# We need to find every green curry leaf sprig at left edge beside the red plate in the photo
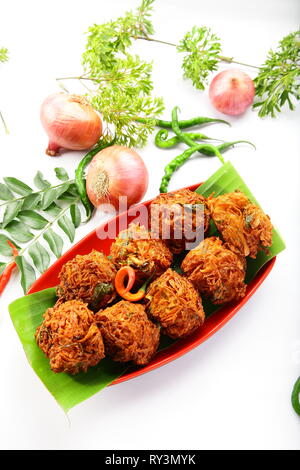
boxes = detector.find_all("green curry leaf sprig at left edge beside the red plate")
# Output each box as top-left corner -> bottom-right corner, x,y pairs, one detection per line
0,168 -> 81,292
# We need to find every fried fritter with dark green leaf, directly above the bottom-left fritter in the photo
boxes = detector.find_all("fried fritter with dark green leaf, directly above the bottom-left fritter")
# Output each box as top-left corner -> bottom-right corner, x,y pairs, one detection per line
57,250 -> 116,311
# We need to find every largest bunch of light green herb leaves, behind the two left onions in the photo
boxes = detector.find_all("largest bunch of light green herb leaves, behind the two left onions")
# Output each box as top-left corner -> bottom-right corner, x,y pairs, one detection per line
82,0 -> 164,146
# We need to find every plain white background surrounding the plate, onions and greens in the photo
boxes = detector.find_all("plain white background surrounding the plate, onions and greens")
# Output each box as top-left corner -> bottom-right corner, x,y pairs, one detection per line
0,0 -> 300,449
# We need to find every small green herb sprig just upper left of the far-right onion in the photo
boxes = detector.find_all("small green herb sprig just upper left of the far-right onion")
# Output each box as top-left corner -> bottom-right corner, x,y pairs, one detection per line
177,26 -> 221,90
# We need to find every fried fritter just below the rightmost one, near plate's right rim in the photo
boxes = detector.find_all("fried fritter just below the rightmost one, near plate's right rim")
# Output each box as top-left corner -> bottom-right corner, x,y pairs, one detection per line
181,237 -> 246,304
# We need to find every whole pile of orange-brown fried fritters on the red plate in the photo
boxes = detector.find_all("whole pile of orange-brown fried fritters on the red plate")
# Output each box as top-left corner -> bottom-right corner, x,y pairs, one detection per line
36,190 -> 272,374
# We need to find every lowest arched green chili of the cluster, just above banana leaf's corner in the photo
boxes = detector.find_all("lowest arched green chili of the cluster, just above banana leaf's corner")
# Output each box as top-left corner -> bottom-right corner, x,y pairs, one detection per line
159,143 -> 224,193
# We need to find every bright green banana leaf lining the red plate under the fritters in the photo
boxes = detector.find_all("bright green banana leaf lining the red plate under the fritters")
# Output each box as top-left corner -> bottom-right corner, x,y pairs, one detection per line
9,162 -> 285,411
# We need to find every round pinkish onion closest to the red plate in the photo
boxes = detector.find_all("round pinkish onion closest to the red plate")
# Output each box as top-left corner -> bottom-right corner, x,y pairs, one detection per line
86,145 -> 149,209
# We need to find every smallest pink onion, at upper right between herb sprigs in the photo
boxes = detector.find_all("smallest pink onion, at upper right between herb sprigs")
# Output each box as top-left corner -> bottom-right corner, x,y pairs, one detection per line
209,69 -> 255,116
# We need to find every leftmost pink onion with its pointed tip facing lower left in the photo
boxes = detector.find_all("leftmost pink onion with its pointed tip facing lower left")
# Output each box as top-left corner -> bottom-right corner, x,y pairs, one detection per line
40,93 -> 102,156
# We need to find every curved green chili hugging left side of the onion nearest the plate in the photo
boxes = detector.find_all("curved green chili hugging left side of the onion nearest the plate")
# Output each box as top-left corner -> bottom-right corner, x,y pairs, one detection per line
75,139 -> 115,222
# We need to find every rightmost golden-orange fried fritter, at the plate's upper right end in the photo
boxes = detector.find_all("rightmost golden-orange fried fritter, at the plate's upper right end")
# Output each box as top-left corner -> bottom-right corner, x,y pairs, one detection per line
207,191 -> 273,258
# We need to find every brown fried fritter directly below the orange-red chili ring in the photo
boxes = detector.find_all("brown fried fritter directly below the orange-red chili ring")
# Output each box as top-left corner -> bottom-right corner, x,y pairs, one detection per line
96,300 -> 160,365
